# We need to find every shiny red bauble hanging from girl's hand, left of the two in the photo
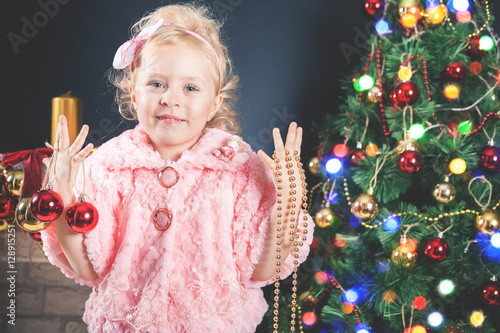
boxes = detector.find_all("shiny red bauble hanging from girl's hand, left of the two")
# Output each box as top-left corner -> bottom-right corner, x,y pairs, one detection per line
30,190 -> 64,222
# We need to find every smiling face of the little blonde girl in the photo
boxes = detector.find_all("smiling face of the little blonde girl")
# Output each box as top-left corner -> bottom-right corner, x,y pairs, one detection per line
131,44 -> 222,160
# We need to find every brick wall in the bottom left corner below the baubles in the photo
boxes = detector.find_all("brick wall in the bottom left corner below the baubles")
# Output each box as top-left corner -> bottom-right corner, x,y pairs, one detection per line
0,226 -> 91,333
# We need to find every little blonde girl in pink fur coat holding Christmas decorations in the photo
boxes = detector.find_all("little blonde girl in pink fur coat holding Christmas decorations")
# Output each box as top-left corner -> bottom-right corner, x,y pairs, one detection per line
42,5 -> 313,333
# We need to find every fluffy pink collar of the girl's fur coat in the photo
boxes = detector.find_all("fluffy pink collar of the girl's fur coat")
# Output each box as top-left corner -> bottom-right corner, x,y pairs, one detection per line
89,124 -> 251,171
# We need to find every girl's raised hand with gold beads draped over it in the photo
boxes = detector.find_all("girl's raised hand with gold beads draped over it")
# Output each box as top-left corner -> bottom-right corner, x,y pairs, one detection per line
258,122 -> 303,201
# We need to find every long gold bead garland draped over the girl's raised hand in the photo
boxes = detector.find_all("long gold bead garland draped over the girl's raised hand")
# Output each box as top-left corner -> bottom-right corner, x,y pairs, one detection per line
273,150 -> 308,333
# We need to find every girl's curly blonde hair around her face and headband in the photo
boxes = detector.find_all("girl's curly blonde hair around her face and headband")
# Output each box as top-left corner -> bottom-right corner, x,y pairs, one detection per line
108,4 -> 241,134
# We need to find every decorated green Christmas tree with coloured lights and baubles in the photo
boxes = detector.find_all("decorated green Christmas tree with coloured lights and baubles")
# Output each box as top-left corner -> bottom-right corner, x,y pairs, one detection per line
286,0 -> 500,333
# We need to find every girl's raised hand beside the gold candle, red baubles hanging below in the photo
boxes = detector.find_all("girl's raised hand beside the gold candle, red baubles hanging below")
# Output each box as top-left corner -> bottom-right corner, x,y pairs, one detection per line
43,116 -> 94,204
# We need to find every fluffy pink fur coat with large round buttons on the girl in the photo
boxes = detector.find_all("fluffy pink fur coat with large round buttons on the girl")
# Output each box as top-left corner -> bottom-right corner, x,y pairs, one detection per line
42,125 -> 313,333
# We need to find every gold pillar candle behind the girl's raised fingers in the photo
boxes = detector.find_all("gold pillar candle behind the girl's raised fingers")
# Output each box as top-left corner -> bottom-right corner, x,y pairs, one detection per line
52,91 -> 82,145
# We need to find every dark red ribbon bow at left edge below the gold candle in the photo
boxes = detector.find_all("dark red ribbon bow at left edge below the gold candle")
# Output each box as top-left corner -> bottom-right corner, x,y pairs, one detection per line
2,148 -> 52,199
